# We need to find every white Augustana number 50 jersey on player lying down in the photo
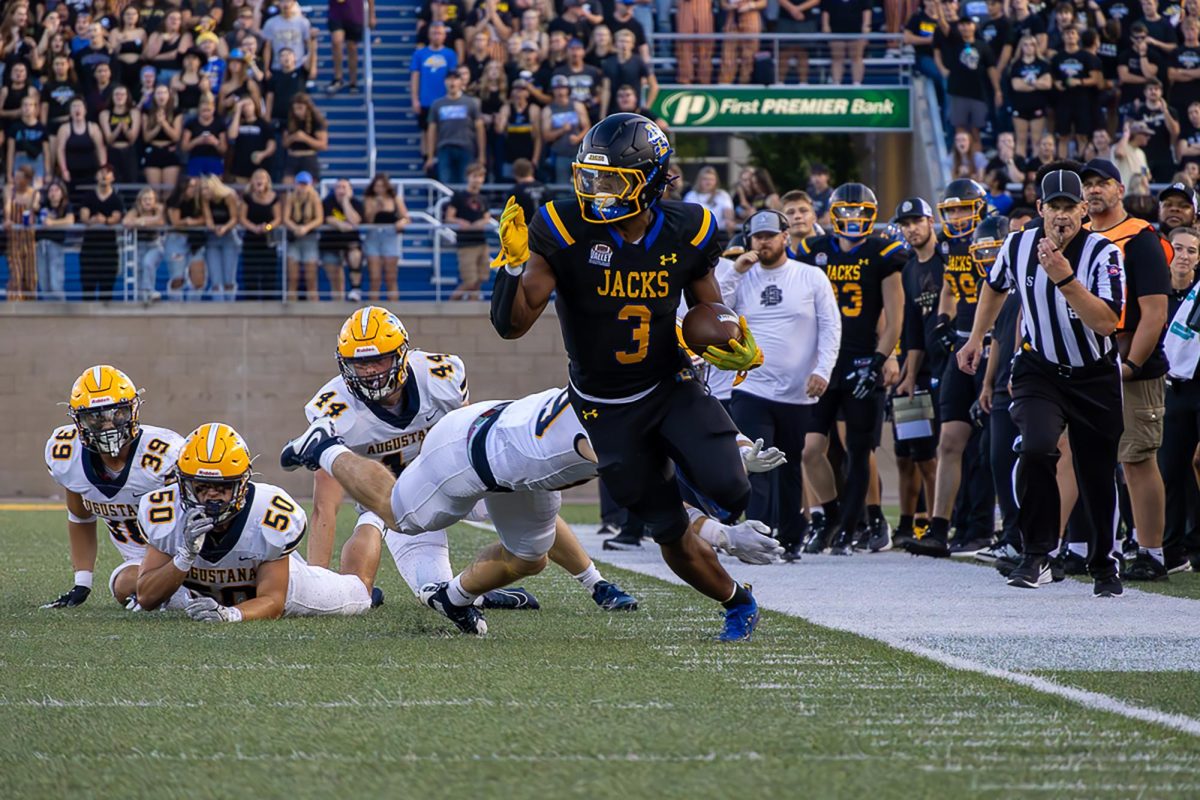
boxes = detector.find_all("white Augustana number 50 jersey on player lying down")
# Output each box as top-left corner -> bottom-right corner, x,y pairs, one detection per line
138,481 -> 308,606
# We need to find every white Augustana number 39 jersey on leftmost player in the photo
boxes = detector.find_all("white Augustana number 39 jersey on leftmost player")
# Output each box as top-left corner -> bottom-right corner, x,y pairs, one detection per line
46,425 -> 184,560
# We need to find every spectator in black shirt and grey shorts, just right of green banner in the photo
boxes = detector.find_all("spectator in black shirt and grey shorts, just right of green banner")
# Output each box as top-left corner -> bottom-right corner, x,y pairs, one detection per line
935,17 -> 1003,138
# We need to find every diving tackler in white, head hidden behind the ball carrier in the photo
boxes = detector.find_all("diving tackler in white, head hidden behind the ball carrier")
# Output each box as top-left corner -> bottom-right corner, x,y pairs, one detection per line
280,389 -> 784,634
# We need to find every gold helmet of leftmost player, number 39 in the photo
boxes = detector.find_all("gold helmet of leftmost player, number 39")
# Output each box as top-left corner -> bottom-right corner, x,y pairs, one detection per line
67,363 -> 142,457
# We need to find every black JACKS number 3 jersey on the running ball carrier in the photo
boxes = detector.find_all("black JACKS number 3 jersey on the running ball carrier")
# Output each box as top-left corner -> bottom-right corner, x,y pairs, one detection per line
529,200 -> 721,398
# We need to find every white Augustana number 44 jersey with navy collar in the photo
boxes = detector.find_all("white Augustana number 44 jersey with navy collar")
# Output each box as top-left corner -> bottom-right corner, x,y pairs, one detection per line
304,350 -> 469,475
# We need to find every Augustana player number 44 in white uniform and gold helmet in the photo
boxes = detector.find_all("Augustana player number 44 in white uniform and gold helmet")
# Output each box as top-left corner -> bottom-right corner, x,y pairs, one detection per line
305,306 -> 637,610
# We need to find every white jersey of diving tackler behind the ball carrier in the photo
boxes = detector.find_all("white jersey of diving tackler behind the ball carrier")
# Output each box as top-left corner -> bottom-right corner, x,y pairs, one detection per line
480,389 -> 596,492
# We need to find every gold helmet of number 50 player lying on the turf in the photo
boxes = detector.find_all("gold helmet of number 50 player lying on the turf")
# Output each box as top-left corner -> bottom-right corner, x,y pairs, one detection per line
175,422 -> 252,524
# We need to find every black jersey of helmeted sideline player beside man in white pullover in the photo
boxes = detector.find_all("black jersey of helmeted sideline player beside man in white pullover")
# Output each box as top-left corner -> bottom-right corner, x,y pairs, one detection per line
797,235 -> 906,357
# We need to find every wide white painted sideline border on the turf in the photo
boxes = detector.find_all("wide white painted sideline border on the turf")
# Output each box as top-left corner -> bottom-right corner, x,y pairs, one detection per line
575,525 -> 1200,736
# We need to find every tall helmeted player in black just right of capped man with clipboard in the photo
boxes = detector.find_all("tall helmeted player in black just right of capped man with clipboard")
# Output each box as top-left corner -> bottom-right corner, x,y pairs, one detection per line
905,178 -> 995,558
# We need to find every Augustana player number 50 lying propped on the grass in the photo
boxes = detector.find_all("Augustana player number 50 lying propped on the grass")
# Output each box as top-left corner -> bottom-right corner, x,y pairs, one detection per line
138,422 -> 372,622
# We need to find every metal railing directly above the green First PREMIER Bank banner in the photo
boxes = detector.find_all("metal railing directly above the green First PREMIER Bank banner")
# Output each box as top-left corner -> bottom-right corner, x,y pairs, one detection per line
652,31 -> 913,85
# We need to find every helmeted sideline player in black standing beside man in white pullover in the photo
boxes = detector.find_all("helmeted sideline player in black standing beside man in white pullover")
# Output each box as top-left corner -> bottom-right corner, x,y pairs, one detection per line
790,184 -> 905,558
